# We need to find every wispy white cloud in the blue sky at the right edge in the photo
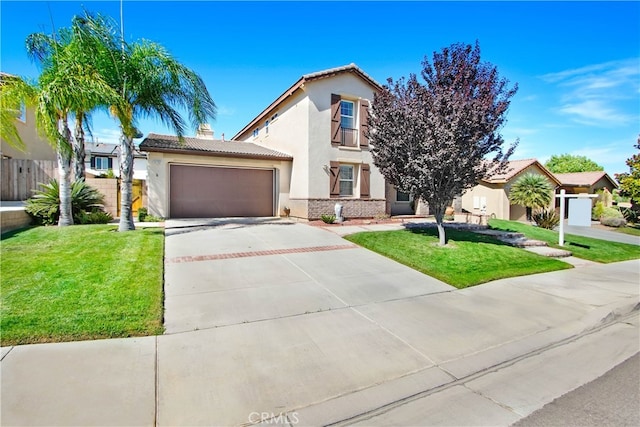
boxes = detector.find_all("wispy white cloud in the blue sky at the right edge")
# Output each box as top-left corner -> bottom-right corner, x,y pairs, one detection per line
541,58 -> 640,127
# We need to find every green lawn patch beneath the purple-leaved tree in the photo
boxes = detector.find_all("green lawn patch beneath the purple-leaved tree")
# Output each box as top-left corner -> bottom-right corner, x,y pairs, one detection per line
345,228 -> 572,289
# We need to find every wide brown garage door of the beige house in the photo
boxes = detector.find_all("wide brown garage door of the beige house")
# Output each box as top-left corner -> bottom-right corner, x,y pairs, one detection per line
169,165 -> 273,218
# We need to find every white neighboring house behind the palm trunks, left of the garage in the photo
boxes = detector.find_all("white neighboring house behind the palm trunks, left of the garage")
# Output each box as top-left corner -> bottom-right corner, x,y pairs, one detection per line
84,142 -> 147,180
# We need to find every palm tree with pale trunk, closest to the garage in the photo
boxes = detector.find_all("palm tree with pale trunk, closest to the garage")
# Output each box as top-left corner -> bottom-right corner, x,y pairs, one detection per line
77,15 -> 216,231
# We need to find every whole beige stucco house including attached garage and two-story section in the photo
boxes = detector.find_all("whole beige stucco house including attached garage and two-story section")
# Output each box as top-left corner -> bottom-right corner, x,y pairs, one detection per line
140,64 -> 396,219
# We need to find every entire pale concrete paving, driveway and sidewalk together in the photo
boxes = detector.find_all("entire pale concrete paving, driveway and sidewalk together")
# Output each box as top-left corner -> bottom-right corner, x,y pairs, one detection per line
0,219 -> 640,426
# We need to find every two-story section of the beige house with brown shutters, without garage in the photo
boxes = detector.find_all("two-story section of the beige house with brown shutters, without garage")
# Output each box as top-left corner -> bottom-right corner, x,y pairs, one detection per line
233,64 -> 385,218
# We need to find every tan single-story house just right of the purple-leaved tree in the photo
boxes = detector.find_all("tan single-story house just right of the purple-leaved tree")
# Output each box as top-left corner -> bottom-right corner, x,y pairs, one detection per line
462,159 -> 560,221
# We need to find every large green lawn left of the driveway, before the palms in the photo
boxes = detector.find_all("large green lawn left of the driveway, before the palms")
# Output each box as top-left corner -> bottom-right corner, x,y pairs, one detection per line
0,225 -> 164,346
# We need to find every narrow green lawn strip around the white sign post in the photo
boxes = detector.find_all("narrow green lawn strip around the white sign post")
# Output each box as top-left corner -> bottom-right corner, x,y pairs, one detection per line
489,219 -> 640,263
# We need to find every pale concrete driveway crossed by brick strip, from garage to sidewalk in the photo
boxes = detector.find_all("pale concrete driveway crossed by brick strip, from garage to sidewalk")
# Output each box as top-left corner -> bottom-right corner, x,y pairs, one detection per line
165,218 -> 454,334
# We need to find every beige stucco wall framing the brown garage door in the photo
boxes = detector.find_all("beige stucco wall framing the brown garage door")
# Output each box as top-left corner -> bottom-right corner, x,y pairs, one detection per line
147,152 -> 291,218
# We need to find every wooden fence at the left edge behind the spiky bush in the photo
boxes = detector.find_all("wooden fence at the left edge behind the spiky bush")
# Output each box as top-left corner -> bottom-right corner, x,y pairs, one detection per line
0,159 -> 58,201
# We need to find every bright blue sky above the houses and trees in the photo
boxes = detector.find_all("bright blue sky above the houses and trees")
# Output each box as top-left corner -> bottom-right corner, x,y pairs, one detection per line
0,0 -> 640,175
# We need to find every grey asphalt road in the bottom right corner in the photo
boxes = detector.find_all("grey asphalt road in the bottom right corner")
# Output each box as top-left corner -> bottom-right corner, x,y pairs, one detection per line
514,354 -> 640,427
